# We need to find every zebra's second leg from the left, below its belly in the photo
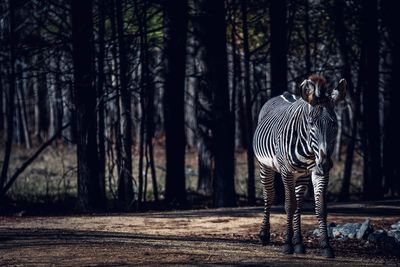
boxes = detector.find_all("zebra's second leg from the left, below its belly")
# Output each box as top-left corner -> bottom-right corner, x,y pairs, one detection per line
282,173 -> 297,254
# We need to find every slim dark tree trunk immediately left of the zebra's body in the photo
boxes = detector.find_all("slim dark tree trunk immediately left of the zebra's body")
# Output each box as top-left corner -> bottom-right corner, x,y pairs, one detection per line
241,0 -> 256,205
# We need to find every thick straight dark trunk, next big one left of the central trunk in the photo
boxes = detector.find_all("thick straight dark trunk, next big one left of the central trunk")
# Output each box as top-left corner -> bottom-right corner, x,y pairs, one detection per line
164,1 -> 188,205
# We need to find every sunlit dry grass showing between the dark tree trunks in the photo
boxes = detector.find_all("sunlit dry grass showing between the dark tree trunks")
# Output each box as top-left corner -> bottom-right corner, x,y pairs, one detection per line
0,143 -> 362,202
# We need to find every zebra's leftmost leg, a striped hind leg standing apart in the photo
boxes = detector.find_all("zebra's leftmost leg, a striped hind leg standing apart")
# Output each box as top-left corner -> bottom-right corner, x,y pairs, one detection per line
259,164 -> 275,246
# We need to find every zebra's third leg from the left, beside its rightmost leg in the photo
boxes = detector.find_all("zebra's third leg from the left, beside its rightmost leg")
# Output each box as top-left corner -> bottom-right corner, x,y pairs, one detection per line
293,181 -> 309,254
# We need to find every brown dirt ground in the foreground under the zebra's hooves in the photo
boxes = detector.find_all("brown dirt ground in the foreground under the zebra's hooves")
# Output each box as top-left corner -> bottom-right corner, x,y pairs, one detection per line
0,203 -> 400,266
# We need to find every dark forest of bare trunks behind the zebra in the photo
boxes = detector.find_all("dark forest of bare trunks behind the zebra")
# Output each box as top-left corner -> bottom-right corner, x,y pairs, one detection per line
0,0 -> 400,214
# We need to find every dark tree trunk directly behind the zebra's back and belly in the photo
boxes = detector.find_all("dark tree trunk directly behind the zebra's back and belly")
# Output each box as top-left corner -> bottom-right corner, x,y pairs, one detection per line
270,0 -> 288,203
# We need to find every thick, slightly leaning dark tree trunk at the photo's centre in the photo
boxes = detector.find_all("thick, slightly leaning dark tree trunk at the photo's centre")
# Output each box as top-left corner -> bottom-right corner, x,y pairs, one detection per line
202,0 -> 236,207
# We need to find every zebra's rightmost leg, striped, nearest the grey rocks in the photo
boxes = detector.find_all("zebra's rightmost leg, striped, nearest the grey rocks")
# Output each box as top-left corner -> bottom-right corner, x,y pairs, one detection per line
312,173 -> 335,258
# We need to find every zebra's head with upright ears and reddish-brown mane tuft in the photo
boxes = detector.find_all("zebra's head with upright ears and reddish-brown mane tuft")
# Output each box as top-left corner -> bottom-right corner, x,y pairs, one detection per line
300,75 -> 347,175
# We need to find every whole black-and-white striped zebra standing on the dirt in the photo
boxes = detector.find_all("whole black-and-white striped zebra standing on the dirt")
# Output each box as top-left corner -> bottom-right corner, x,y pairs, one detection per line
253,74 -> 347,258
